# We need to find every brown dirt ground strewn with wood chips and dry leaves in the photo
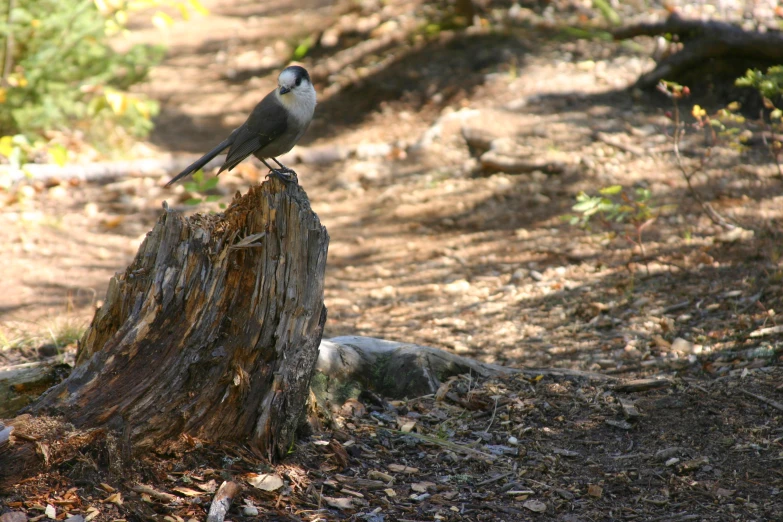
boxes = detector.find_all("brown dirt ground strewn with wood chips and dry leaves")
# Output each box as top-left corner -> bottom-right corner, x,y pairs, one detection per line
0,0 -> 783,522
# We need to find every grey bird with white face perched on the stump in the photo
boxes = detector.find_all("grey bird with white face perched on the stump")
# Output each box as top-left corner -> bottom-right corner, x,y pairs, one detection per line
166,65 -> 316,187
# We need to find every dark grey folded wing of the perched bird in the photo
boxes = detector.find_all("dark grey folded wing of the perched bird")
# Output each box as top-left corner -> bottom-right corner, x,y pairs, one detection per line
219,92 -> 288,173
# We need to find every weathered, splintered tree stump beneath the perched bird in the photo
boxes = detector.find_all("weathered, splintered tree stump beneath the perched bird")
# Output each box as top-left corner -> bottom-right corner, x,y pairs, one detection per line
26,179 -> 329,460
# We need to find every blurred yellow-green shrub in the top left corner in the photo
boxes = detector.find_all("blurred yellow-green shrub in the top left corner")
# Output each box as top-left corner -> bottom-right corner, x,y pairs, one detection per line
0,0 -> 205,159
